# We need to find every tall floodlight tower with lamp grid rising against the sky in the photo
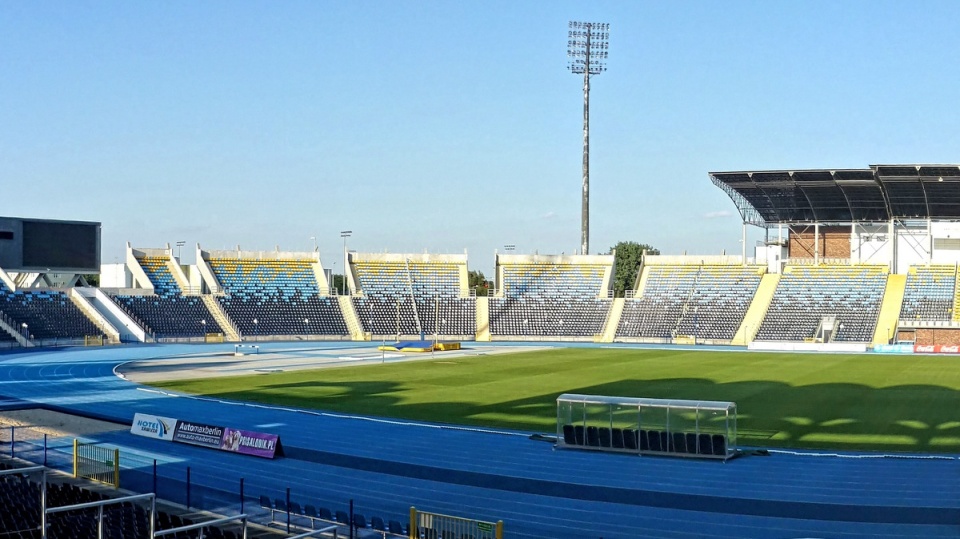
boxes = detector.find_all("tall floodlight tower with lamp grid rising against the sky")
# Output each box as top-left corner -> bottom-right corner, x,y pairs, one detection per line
567,21 -> 610,255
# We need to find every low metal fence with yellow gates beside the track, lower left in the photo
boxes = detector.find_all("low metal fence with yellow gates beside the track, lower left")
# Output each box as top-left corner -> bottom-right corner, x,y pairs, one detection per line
0,434 -> 503,539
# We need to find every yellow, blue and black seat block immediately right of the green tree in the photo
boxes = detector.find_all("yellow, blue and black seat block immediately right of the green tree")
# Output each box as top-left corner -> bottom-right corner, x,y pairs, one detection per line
617,265 -> 763,340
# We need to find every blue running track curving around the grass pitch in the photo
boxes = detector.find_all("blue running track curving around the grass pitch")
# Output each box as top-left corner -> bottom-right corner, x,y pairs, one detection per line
0,343 -> 960,539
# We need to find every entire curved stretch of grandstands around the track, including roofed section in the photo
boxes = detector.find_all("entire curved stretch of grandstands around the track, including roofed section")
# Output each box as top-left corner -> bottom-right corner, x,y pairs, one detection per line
0,165 -> 960,350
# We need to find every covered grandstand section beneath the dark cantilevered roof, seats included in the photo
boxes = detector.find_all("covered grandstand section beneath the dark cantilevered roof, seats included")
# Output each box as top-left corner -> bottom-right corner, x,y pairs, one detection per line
710,164 -> 960,348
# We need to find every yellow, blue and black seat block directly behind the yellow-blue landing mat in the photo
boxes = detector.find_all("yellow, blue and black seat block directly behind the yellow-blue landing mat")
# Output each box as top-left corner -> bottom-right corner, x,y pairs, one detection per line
352,260 -> 477,335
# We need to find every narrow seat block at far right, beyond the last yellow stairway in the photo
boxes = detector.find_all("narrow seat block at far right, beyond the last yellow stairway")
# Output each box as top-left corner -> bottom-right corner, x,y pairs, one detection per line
900,265 -> 957,322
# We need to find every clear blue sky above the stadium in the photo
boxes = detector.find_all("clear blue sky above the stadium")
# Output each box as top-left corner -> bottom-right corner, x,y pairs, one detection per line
0,0 -> 960,275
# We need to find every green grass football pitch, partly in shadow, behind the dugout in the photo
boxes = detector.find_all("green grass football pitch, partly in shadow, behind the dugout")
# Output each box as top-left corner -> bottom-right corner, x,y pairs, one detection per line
153,348 -> 960,453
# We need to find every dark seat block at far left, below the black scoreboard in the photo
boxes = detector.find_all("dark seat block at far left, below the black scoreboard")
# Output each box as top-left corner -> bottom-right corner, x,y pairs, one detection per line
0,290 -> 103,340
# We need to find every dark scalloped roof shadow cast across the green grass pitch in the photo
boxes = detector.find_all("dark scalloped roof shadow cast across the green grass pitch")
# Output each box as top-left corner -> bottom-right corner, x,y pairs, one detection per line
158,378 -> 960,453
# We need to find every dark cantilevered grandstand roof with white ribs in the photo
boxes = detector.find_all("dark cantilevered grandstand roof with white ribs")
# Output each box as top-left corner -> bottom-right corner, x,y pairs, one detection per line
710,165 -> 960,226
